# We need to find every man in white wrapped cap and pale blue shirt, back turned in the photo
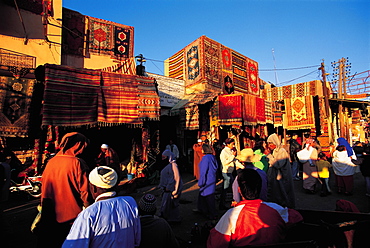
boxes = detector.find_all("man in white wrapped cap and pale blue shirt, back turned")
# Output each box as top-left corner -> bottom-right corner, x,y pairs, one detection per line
62,166 -> 141,248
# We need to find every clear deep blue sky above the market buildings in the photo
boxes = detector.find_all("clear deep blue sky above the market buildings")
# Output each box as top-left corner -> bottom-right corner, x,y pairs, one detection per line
63,0 -> 370,86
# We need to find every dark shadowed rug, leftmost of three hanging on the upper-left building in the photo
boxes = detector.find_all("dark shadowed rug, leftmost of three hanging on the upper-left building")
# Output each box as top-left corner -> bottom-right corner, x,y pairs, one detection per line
62,8 -> 85,56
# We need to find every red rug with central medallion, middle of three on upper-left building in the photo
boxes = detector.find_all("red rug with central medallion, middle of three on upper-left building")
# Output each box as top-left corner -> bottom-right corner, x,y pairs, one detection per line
88,17 -> 113,55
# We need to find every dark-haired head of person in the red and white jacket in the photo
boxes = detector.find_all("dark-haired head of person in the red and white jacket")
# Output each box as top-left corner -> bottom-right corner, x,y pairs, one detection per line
238,169 -> 262,200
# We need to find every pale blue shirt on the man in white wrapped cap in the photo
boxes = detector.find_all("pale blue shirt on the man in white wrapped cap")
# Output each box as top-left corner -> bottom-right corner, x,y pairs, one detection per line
62,196 -> 141,248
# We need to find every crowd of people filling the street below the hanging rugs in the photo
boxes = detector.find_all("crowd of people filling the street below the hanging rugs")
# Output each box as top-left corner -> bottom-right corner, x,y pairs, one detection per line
2,132 -> 370,248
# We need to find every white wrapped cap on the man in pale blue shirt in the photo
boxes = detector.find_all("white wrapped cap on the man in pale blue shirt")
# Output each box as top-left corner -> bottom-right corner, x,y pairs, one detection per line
89,166 -> 118,189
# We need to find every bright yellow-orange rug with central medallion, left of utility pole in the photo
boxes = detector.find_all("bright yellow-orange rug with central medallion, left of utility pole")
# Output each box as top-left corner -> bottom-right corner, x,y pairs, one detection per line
284,96 -> 315,130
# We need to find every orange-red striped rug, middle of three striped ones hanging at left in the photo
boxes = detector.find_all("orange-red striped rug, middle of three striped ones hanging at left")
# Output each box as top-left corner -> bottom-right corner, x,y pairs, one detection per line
98,72 -> 141,126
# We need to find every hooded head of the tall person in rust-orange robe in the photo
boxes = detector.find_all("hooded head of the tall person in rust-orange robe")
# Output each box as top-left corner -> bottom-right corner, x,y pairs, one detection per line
60,132 -> 90,155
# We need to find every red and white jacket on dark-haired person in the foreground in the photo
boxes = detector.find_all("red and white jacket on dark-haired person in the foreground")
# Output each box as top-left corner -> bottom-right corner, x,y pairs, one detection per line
207,199 -> 303,248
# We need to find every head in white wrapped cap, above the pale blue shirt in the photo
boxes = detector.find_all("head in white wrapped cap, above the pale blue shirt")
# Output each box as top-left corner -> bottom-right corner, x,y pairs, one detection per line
89,166 -> 118,199
